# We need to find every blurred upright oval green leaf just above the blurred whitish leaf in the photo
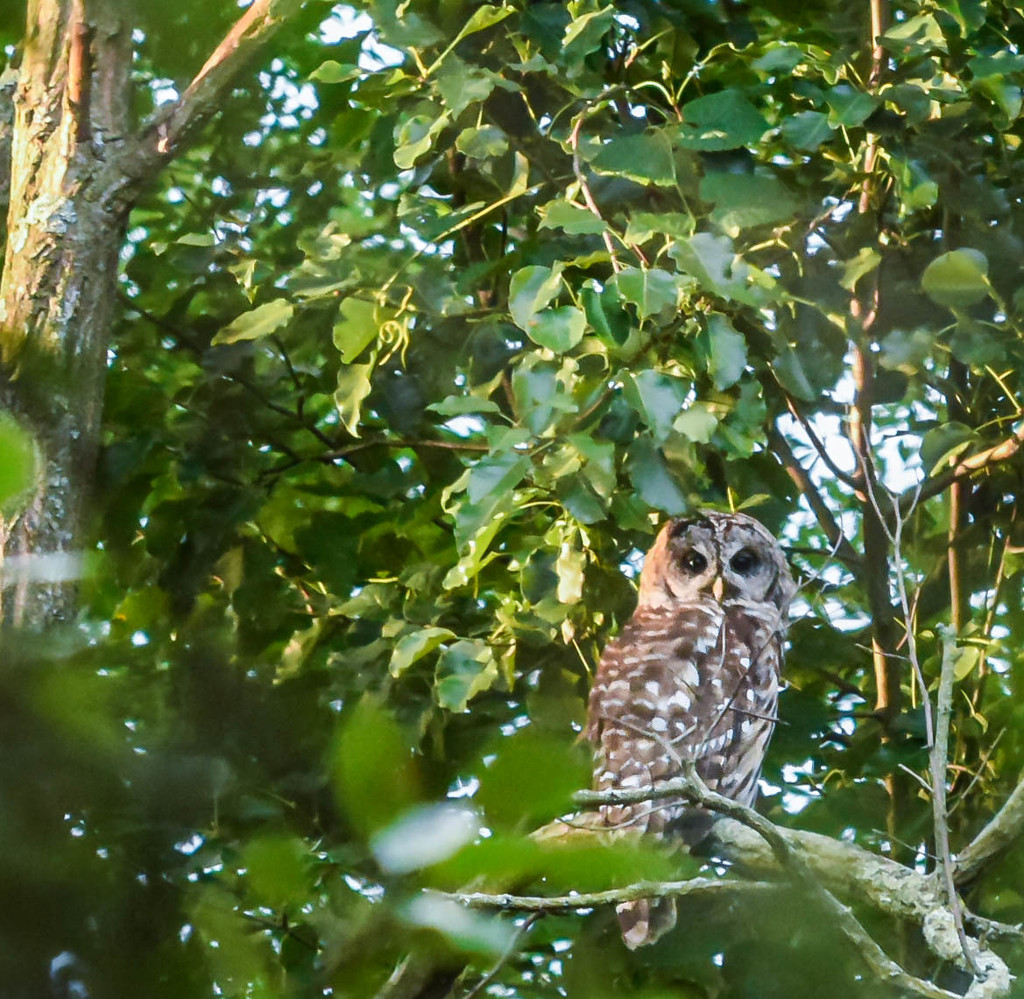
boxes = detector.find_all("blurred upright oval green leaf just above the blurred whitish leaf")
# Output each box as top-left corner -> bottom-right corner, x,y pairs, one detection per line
331,698 -> 419,835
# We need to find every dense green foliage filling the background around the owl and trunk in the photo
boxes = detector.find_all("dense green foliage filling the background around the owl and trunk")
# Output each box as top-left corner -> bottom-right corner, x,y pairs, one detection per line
0,0 -> 1024,999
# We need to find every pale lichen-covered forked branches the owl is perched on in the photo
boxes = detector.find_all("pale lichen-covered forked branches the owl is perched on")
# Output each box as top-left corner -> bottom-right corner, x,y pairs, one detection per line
437,765 -> 1024,999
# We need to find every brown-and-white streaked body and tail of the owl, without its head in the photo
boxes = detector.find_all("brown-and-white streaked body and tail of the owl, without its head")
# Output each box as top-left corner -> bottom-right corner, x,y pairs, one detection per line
587,601 -> 781,948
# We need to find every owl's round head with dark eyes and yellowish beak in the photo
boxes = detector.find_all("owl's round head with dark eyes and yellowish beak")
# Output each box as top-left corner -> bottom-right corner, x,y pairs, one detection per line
639,511 -> 797,617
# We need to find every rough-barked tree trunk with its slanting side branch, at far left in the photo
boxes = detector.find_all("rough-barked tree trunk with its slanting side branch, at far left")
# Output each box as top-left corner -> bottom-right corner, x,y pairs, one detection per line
0,0 -> 302,628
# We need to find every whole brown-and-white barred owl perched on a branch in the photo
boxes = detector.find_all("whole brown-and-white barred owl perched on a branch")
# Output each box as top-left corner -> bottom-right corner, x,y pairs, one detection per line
587,512 -> 796,949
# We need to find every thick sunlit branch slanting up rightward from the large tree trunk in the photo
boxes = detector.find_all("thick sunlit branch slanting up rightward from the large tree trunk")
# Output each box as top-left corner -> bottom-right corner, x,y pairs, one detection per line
126,0 -> 304,183
